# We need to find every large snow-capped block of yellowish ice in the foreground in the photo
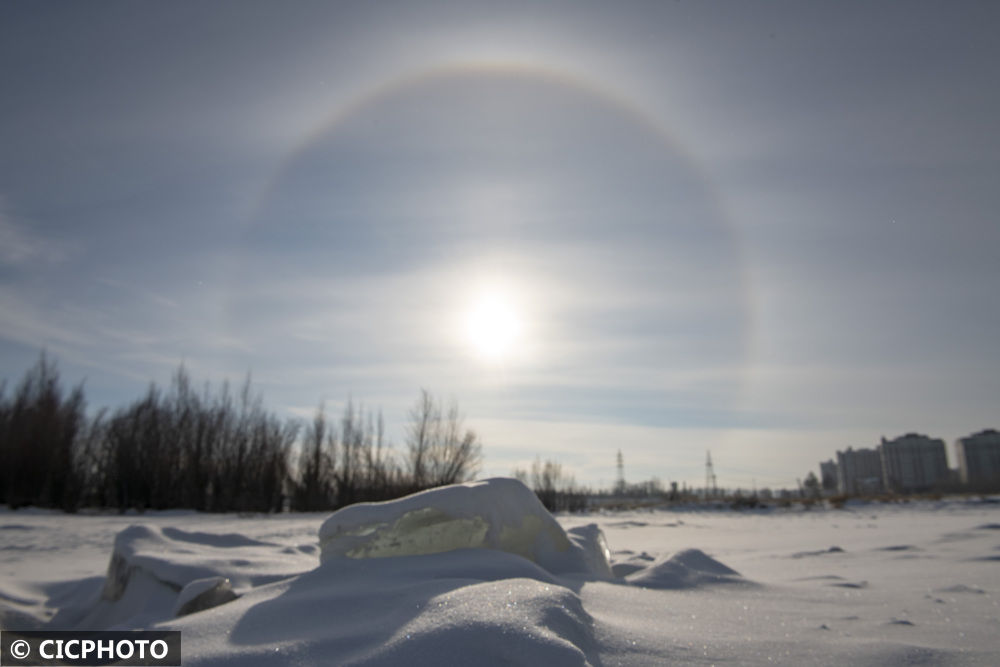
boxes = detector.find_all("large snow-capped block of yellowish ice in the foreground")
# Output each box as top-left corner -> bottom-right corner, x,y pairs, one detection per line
319,477 -> 612,578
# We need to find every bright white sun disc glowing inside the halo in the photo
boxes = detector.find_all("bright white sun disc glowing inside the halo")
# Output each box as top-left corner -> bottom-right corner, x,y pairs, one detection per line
465,290 -> 524,363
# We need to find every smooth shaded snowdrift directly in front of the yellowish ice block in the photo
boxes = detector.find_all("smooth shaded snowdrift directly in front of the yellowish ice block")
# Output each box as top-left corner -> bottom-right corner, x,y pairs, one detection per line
171,549 -> 601,667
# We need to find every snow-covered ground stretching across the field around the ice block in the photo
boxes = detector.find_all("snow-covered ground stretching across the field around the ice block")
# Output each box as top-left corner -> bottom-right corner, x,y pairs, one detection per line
0,485 -> 1000,666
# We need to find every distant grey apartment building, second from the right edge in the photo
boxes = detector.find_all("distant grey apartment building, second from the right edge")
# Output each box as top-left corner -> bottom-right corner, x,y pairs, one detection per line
879,433 -> 948,493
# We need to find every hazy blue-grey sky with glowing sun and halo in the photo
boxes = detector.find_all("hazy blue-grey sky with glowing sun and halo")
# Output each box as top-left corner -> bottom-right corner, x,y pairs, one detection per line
0,0 -> 1000,488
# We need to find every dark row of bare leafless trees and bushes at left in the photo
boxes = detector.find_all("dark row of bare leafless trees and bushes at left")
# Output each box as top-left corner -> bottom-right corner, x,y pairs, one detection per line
0,354 -> 482,512
